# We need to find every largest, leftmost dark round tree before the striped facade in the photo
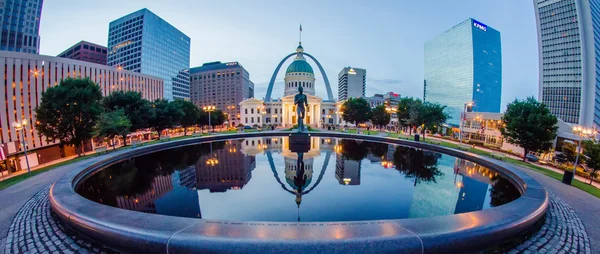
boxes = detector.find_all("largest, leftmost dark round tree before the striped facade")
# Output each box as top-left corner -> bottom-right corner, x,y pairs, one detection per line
35,78 -> 103,156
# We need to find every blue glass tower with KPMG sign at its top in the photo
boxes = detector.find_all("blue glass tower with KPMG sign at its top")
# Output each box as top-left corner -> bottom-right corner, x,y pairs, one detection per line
423,18 -> 502,125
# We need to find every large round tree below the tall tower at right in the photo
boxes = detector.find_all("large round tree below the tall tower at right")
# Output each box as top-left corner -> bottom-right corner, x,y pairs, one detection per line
500,97 -> 558,161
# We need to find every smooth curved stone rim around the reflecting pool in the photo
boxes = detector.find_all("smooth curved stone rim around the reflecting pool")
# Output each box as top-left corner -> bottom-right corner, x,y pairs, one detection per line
49,132 -> 549,253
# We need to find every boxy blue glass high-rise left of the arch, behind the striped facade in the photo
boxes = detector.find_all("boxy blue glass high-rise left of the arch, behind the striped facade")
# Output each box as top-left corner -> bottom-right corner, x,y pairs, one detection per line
108,8 -> 190,100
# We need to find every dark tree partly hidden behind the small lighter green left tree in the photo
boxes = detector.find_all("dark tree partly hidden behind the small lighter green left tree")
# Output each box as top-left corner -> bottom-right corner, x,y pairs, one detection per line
102,91 -> 150,145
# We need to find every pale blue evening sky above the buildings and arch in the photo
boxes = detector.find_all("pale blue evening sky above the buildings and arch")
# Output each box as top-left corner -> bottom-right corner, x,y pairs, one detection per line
40,0 -> 539,109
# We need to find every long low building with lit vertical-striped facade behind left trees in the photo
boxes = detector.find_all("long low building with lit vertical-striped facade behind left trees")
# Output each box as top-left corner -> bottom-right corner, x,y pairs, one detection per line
0,51 -> 163,175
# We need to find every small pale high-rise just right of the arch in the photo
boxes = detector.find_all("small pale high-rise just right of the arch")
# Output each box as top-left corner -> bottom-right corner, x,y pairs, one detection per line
338,67 -> 367,101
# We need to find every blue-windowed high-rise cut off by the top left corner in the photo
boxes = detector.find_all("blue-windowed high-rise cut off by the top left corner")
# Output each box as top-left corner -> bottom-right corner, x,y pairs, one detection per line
0,0 -> 44,54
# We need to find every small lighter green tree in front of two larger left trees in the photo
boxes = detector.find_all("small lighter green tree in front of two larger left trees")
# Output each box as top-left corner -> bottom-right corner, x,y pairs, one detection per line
96,109 -> 131,150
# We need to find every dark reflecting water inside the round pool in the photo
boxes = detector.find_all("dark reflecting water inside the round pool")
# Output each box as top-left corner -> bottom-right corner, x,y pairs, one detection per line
76,136 -> 520,222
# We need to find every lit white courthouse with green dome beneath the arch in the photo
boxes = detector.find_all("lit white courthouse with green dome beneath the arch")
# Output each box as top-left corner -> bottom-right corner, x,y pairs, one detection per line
239,39 -> 341,128
